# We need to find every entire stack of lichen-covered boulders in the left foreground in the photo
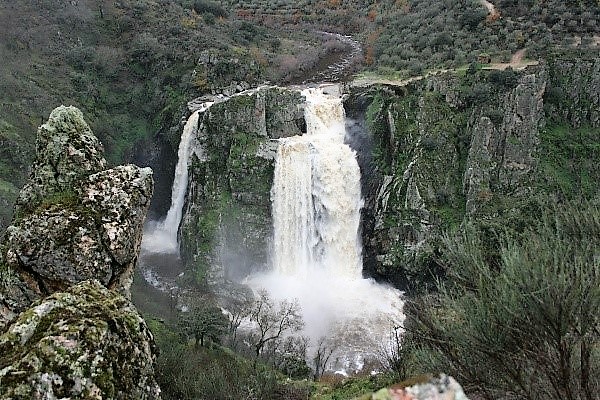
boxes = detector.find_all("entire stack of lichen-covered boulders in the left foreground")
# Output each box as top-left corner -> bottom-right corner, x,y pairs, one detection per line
0,107 -> 159,399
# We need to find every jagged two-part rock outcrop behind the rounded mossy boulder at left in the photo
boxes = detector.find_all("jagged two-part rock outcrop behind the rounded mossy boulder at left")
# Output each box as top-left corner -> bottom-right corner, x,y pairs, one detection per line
0,107 -> 153,328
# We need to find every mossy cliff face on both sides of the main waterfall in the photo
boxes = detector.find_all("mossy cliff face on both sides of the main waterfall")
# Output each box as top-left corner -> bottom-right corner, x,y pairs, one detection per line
166,51 -> 599,291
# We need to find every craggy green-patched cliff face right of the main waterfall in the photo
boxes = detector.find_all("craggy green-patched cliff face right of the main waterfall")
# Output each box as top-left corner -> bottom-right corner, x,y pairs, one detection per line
348,54 -> 600,290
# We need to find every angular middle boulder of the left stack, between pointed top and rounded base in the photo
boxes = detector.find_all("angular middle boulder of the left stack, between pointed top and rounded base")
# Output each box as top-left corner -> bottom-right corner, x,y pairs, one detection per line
4,165 -> 152,307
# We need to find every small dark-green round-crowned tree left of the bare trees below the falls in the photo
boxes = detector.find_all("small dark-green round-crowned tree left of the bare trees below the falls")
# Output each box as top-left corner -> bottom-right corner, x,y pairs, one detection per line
179,300 -> 228,346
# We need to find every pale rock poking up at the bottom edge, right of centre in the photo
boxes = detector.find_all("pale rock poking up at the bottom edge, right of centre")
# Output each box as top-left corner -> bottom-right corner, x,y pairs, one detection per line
357,374 -> 468,400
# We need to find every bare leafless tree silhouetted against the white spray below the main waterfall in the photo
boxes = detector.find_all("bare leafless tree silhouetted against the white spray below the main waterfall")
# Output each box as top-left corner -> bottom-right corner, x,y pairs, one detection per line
249,290 -> 304,357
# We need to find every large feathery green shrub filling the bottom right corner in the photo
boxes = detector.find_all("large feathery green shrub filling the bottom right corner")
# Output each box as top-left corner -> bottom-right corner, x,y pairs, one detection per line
401,203 -> 600,400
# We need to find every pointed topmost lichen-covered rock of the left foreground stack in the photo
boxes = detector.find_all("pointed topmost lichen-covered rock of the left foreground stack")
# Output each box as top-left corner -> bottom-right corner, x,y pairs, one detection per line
16,106 -> 106,213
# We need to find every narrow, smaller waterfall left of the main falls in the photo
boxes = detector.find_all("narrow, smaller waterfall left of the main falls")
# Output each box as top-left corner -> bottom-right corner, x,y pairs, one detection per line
142,102 -> 213,254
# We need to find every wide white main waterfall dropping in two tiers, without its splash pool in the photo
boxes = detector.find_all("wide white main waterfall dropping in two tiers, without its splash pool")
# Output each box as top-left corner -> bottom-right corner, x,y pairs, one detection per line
271,89 -> 362,278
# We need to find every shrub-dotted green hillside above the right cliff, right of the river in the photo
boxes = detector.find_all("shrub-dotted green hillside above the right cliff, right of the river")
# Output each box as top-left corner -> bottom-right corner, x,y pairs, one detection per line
365,0 -> 600,72
